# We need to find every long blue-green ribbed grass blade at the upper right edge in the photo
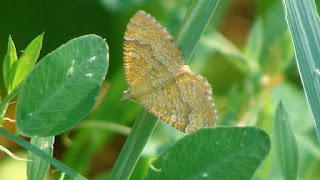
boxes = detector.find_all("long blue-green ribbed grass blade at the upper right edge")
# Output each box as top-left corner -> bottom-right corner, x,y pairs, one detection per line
282,0 -> 320,141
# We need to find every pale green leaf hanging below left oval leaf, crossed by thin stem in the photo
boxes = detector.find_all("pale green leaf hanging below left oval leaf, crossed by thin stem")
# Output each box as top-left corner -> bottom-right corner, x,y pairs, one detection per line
27,136 -> 54,180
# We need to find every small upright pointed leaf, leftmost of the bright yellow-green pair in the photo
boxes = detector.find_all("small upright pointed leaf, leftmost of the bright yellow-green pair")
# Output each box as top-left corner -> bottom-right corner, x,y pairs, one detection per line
2,36 -> 18,93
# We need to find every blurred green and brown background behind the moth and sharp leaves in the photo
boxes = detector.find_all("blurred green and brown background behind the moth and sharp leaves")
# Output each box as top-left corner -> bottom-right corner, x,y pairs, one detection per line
0,0 -> 320,179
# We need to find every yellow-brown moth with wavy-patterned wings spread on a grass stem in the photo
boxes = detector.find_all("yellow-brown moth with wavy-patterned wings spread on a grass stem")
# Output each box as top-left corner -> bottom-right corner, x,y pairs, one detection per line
123,10 -> 218,134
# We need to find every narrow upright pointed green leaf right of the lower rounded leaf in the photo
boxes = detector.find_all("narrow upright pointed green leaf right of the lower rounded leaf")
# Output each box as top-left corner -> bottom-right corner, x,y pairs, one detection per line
273,101 -> 299,180
